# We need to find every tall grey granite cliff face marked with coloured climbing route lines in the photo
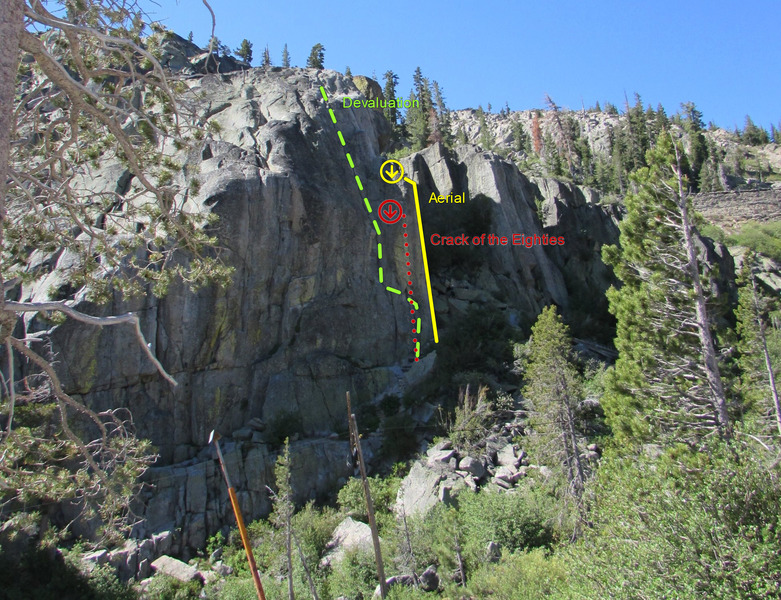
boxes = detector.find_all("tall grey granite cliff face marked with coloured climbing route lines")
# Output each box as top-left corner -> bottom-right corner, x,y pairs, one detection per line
10,68 -> 628,552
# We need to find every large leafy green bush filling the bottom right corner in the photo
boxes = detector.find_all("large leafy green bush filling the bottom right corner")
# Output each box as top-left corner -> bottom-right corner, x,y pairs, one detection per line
568,442 -> 781,600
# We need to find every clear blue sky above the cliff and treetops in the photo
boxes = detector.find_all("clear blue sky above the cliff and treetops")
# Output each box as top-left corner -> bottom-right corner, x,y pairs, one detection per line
147,0 -> 781,129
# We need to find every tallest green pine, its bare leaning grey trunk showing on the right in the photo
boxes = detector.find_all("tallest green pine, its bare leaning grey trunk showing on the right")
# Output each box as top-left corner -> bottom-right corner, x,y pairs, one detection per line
602,134 -> 731,442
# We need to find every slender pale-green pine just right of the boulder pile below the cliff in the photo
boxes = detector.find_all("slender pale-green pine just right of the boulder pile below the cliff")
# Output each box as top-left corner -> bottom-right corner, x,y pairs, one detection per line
523,306 -> 585,497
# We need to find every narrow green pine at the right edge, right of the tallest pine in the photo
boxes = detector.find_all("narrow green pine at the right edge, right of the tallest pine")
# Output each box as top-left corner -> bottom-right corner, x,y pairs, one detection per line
735,251 -> 781,436
